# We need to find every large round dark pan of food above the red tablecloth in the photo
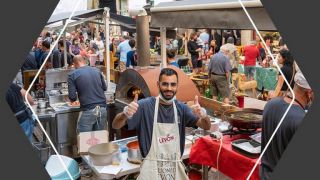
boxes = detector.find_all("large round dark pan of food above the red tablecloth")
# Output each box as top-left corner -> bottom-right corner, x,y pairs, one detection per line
222,108 -> 263,130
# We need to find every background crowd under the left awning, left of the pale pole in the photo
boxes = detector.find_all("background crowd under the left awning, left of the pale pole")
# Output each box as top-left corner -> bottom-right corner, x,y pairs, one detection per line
21,26 -> 104,72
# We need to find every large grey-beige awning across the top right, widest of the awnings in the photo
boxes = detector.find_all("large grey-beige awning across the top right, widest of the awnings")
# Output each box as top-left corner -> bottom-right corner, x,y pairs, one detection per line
150,0 -> 277,31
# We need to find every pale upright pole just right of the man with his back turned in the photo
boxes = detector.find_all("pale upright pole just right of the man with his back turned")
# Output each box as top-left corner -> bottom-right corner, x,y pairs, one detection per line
103,7 -> 110,91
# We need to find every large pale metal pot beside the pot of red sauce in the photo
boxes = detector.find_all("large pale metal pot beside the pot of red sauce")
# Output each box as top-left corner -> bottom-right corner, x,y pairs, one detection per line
88,143 -> 119,166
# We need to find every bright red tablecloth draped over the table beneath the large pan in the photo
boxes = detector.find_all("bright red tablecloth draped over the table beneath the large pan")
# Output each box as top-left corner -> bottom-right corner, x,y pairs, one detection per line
189,135 -> 259,180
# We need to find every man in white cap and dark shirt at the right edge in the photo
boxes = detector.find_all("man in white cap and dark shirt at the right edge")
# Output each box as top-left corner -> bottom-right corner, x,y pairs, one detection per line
260,71 -> 314,179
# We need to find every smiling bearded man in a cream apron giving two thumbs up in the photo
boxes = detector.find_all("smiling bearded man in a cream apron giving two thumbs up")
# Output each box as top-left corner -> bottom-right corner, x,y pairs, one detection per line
112,68 -> 211,179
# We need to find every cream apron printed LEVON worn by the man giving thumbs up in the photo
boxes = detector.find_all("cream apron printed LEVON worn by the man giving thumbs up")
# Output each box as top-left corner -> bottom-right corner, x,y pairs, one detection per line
138,96 -> 189,180
